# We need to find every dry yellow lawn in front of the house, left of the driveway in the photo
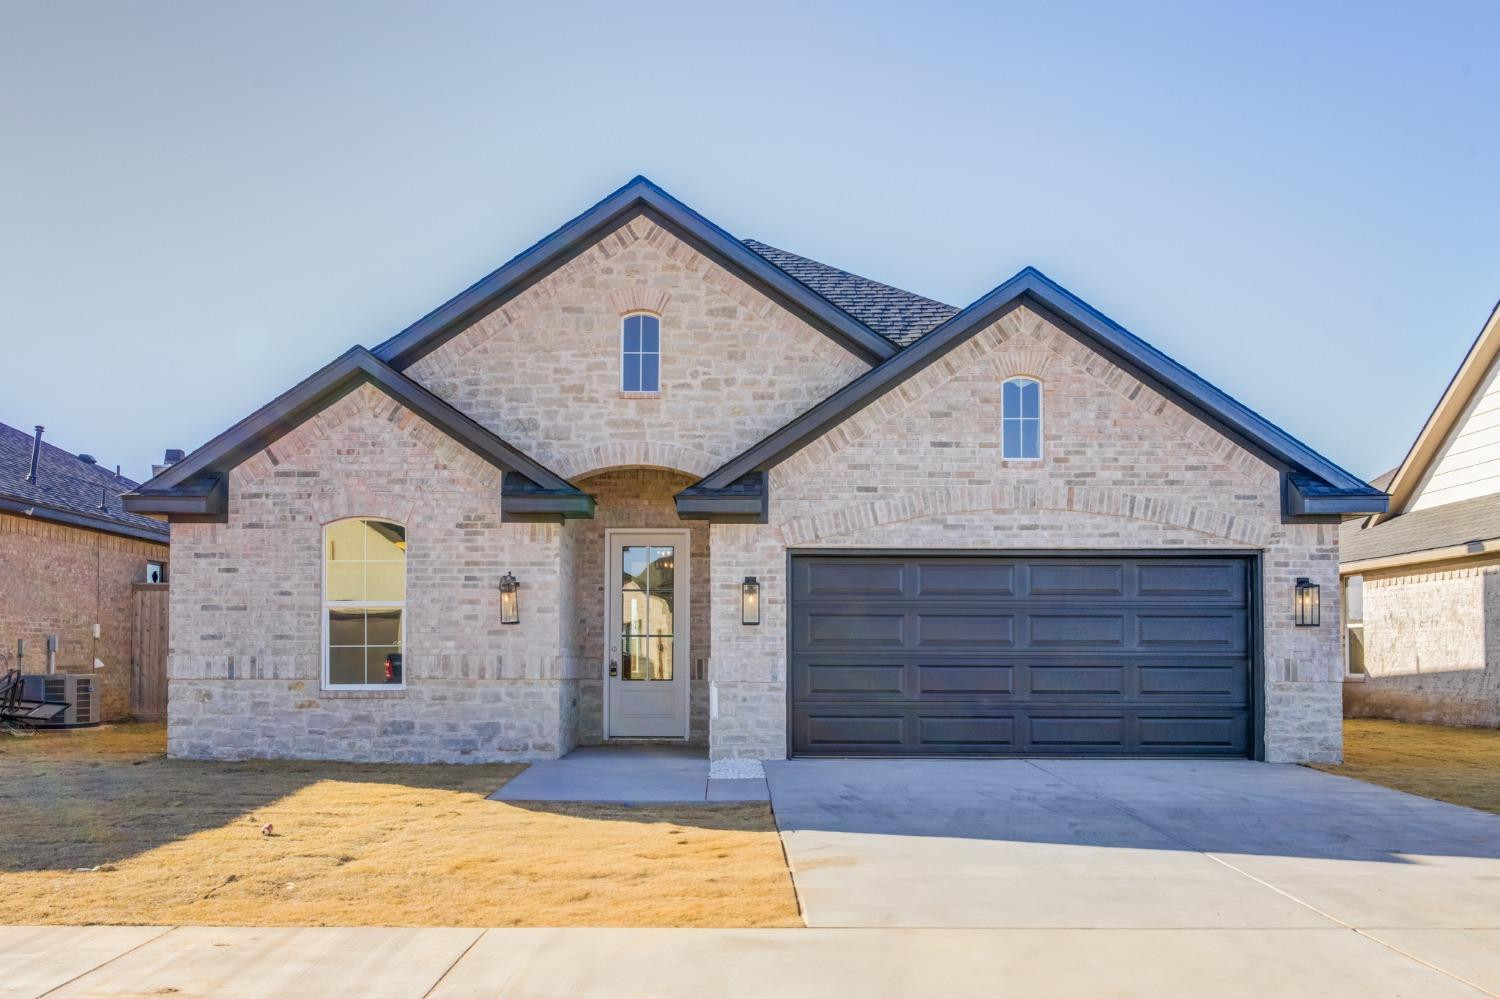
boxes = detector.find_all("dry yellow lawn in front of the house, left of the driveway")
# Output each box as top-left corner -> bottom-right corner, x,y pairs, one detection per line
0,725 -> 801,927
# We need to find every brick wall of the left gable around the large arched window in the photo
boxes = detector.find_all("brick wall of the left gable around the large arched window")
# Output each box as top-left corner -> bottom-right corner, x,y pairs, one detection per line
168,386 -> 576,762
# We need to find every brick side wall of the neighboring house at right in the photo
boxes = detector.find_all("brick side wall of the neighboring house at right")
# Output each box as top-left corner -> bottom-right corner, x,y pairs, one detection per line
1344,564 -> 1500,728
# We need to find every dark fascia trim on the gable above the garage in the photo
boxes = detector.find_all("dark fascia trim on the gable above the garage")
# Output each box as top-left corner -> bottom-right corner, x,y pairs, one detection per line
692,267 -> 1371,513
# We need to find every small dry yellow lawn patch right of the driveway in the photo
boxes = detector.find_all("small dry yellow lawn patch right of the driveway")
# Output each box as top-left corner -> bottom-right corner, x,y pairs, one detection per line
1317,719 -> 1500,813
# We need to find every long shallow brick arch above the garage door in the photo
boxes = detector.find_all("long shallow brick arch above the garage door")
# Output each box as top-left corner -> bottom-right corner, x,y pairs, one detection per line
782,485 -> 1272,548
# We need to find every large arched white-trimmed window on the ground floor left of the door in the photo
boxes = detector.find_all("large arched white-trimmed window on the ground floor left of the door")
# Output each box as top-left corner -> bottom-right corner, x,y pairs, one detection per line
323,518 -> 407,690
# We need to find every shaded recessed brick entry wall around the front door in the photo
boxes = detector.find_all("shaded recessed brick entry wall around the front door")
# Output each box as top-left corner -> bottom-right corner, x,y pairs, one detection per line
564,468 -> 711,746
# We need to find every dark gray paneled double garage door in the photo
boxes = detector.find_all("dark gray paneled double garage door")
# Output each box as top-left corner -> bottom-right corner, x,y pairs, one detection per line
791,555 -> 1251,756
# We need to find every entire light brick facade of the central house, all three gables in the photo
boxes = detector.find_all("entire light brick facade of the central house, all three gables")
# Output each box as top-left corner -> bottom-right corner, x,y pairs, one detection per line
170,231 -> 1343,762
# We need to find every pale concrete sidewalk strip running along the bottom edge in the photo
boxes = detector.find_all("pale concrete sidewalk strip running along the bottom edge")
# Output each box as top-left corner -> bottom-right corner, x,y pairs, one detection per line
0,927 -> 1500,999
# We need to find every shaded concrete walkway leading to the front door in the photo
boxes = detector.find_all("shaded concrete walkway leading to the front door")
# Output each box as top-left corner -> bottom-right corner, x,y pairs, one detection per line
491,746 -> 768,804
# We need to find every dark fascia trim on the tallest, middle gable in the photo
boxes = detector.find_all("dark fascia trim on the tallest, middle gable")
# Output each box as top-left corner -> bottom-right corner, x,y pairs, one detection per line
375,177 -> 897,369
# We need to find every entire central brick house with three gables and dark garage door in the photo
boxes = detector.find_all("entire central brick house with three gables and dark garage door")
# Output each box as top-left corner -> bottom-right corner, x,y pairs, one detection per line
126,179 -> 1386,774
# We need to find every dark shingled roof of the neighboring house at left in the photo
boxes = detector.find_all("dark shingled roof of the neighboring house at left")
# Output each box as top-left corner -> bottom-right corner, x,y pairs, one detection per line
0,423 -> 167,543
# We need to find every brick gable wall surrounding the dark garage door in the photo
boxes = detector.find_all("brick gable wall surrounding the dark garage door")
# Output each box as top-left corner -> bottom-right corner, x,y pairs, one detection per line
710,309 -> 1343,761
